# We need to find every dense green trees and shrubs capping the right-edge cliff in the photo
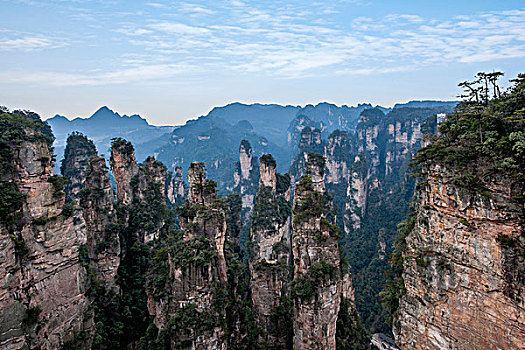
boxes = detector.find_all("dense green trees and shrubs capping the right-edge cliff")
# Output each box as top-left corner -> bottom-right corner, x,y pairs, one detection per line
413,73 -> 525,185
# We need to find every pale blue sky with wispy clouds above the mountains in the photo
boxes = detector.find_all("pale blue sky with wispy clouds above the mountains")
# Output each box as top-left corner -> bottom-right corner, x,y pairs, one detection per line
0,0 -> 525,125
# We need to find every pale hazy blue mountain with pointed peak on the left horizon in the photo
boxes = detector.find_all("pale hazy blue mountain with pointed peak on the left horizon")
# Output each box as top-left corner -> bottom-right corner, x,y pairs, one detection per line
46,106 -> 176,172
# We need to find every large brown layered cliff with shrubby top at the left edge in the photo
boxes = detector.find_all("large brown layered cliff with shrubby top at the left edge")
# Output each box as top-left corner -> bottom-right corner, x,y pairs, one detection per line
0,113 -> 93,349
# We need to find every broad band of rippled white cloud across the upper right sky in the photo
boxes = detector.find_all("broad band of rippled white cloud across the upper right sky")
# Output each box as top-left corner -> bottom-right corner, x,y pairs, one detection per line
112,5 -> 525,77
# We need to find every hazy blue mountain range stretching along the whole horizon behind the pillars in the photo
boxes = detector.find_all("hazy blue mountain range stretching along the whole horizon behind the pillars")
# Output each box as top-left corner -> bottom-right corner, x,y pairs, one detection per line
47,101 -> 456,189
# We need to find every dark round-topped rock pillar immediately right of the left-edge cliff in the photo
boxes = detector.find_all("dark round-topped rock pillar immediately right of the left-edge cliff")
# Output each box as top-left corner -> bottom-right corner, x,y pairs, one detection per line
60,133 -> 120,293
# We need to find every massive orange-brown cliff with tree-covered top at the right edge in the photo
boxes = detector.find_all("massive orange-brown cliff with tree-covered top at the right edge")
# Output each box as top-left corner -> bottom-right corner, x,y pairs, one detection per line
383,77 -> 525,349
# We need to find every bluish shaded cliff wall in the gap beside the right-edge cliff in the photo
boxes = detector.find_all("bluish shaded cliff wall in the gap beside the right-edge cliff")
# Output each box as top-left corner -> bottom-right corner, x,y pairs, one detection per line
332,108 -> 436,332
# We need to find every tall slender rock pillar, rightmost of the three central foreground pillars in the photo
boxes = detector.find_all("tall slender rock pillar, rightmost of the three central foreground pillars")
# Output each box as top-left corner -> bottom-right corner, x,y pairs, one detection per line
291,154 -> 348,349
